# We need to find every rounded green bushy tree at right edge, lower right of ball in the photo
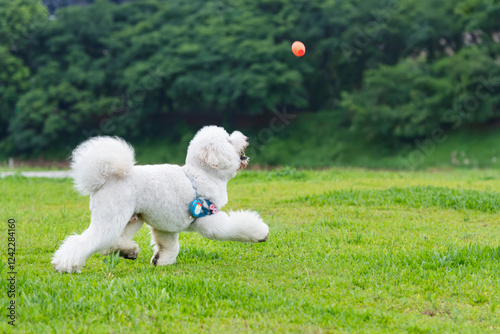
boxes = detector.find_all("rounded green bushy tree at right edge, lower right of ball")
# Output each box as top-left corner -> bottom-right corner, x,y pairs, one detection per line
342,46 -> 500,145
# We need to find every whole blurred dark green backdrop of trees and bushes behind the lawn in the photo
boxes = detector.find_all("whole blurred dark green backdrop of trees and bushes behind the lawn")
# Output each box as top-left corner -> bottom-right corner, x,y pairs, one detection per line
0,0 -> 500,169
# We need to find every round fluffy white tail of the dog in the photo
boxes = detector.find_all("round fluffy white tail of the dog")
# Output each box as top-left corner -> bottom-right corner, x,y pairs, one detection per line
71,137 -> 135,195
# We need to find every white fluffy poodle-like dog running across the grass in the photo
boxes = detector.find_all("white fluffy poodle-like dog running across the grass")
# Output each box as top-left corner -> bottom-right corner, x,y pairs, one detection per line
52,126 -> 269,273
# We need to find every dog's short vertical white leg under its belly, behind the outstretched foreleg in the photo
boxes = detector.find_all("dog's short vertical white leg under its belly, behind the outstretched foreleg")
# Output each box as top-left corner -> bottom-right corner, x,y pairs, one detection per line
151,227 -> 179,266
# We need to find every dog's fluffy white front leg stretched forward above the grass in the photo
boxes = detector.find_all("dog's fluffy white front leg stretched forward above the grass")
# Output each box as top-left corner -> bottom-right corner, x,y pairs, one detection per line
192,211 -> 269,242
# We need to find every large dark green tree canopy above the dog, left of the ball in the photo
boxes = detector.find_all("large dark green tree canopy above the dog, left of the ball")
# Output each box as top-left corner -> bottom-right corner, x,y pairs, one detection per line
2,0 -> 320,151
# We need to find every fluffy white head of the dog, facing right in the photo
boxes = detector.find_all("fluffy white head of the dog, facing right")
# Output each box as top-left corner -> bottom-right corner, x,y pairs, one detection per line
186,125 -> 250,177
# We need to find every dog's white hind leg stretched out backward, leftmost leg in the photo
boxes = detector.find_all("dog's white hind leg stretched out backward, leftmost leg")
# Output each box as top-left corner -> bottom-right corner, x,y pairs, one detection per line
52,205 -> 134,273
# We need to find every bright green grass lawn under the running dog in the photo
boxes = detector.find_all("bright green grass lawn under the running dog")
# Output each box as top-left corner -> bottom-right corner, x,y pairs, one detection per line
0,169 -> 500,333
